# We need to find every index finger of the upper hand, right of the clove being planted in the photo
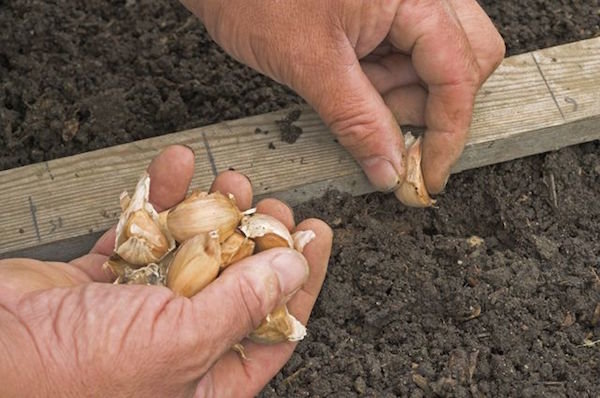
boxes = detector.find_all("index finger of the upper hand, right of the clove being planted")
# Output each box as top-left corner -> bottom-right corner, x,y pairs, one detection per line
390,0 -> 480,193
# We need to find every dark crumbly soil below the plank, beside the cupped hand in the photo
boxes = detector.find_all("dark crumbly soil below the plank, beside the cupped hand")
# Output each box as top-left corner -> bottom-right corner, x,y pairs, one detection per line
270,142 -> 600,397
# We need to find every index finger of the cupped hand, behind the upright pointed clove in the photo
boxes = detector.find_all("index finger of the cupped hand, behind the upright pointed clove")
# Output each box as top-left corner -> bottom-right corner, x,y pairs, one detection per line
71,145 -> 194,282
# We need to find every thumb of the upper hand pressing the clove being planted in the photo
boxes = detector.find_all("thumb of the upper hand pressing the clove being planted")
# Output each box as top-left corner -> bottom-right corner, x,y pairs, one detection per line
294,52 -> 406,191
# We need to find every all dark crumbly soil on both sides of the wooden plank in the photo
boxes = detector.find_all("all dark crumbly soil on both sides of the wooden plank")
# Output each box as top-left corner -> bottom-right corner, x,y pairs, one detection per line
0,0 -> 600,397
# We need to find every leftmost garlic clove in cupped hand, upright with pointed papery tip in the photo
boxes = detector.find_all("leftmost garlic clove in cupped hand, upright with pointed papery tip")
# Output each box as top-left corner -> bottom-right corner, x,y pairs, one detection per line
115,174 -> 175,267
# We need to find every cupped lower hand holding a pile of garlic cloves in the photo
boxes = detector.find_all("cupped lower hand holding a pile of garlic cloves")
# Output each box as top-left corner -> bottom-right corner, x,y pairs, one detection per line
0,146 -> 332,397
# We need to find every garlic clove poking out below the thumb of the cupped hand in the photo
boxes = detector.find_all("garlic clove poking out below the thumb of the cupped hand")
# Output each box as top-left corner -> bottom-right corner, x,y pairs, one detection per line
248,305 -> 306,344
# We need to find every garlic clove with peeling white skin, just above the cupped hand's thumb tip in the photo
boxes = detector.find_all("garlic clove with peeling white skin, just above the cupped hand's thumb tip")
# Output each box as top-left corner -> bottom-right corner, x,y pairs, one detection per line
239,213 -> 294,252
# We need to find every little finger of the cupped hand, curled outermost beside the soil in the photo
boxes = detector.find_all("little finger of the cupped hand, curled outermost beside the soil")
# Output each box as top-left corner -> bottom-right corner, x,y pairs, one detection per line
198,219 -> 333,397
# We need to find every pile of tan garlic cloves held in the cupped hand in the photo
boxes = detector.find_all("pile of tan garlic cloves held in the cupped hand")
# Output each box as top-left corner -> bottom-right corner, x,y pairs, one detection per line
104,174 -> 315,344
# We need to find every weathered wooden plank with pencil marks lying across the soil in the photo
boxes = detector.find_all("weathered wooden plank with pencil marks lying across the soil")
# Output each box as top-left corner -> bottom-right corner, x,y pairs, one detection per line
0,38 -> 600,258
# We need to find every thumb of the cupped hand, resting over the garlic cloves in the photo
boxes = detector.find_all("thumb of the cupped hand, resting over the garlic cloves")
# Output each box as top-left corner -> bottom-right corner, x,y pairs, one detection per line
186,248 -> 309,364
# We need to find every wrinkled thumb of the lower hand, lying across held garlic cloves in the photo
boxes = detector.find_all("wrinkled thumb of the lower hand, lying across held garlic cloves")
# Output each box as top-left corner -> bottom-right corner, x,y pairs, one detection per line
155,248 -> 309,377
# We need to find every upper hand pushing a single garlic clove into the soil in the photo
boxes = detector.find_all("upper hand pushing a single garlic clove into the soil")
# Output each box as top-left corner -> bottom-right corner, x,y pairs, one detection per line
182,0 -> 504,193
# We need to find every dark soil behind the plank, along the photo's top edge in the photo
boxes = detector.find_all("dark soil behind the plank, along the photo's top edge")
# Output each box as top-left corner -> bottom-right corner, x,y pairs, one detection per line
0,0 -> 600,170
